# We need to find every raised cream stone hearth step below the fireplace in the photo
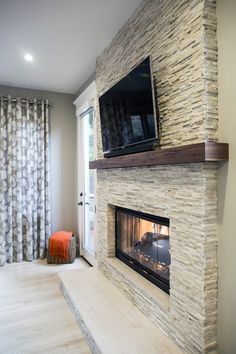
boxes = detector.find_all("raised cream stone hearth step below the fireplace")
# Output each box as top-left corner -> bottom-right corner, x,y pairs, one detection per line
59,268 -> 182,354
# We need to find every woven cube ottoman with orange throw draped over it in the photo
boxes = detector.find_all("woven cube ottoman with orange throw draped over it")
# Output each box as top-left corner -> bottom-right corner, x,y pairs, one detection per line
47,231 -> 76,264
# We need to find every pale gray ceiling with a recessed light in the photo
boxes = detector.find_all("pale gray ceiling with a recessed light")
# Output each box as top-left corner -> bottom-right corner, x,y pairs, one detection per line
0,0 -> 141,94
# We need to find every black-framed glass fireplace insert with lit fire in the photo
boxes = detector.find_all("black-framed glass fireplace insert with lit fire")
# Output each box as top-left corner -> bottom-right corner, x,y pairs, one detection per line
115,207 -> 171,294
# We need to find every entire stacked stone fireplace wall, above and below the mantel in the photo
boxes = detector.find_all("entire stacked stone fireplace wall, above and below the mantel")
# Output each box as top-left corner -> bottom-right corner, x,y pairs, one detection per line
96,0 -> 217,353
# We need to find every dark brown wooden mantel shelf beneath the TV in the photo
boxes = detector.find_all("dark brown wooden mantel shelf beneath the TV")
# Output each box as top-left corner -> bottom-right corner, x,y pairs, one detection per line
89,142 -> 229,170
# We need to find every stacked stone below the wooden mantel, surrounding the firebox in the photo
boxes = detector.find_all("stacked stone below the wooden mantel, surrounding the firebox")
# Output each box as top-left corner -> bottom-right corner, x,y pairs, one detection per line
97,163 -> 217,353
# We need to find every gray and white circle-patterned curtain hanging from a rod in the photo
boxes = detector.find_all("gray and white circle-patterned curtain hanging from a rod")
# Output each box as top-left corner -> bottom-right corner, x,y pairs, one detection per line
0,97 -> 50,265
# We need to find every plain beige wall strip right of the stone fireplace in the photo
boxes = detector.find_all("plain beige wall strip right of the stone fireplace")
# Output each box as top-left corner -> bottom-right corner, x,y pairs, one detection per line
217,0 -> 236,354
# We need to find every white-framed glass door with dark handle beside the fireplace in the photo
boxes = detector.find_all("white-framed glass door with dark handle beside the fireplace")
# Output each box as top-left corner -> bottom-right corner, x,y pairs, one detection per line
78,108 -> 96,265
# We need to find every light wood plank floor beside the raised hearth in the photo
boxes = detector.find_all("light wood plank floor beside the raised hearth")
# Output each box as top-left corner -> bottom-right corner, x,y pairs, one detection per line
0,259 -> 91,354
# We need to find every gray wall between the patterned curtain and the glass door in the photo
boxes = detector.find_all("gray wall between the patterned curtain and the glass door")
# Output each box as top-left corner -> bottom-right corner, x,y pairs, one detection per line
0,86 -> 77,232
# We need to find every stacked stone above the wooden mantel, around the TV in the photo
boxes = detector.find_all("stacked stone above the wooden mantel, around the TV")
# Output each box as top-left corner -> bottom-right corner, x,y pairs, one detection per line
96,0 -> 218,157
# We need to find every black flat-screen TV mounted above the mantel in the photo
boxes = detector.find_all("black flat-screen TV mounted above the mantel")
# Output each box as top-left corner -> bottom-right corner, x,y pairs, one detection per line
99,57 -> 158,157
